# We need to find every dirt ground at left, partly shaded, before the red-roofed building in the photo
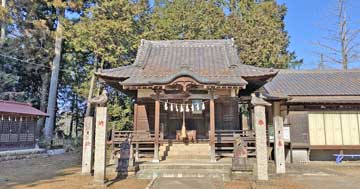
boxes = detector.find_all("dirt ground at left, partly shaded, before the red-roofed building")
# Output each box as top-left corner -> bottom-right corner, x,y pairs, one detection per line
0,153 -> 149,189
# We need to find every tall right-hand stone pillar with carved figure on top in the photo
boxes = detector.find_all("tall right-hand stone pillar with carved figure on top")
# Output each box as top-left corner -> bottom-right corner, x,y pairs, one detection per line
251,94 -> 271,180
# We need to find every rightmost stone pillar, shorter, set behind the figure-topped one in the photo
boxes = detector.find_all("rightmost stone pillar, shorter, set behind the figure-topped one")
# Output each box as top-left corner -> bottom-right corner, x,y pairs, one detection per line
273,101 -> 285,173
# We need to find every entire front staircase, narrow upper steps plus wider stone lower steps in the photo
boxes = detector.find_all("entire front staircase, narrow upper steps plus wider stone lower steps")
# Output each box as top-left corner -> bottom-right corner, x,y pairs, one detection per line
136,144 -> 231,180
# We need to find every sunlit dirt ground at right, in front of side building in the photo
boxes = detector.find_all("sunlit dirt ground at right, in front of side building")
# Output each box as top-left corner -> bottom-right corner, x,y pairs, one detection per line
225,162 -> 360,189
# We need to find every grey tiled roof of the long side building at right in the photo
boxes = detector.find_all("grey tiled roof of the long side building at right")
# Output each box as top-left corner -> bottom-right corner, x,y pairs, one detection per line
264,70 -> 360,96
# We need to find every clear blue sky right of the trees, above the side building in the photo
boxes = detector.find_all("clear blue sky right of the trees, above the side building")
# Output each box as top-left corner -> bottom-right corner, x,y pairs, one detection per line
277,0 -> 360,69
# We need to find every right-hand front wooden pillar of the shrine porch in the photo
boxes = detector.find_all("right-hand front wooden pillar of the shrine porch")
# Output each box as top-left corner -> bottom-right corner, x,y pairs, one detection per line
209,90 -> 216,162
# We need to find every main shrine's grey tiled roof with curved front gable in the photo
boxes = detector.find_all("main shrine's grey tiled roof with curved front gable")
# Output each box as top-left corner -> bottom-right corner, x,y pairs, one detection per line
97,39 -> 276,86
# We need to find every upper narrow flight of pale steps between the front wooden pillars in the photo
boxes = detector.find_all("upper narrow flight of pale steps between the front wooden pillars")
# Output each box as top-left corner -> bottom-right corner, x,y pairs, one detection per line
159,143 -> 210,160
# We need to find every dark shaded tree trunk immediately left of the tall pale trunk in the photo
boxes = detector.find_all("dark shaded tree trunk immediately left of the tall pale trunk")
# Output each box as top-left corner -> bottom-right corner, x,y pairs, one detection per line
36,72 -> 49,136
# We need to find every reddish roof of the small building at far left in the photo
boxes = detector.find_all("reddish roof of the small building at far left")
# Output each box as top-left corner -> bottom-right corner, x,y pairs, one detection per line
0,100 -> 47,116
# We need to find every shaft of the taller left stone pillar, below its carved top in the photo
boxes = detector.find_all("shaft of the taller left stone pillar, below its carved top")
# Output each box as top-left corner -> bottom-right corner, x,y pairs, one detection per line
94,107 -> 107,183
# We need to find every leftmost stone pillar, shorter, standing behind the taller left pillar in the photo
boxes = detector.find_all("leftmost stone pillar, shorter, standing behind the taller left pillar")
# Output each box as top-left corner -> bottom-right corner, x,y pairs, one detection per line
81,116 -> 94,174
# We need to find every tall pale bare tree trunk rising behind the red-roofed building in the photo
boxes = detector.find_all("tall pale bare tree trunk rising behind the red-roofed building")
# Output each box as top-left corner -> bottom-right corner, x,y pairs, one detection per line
44,11 -> 63,140
